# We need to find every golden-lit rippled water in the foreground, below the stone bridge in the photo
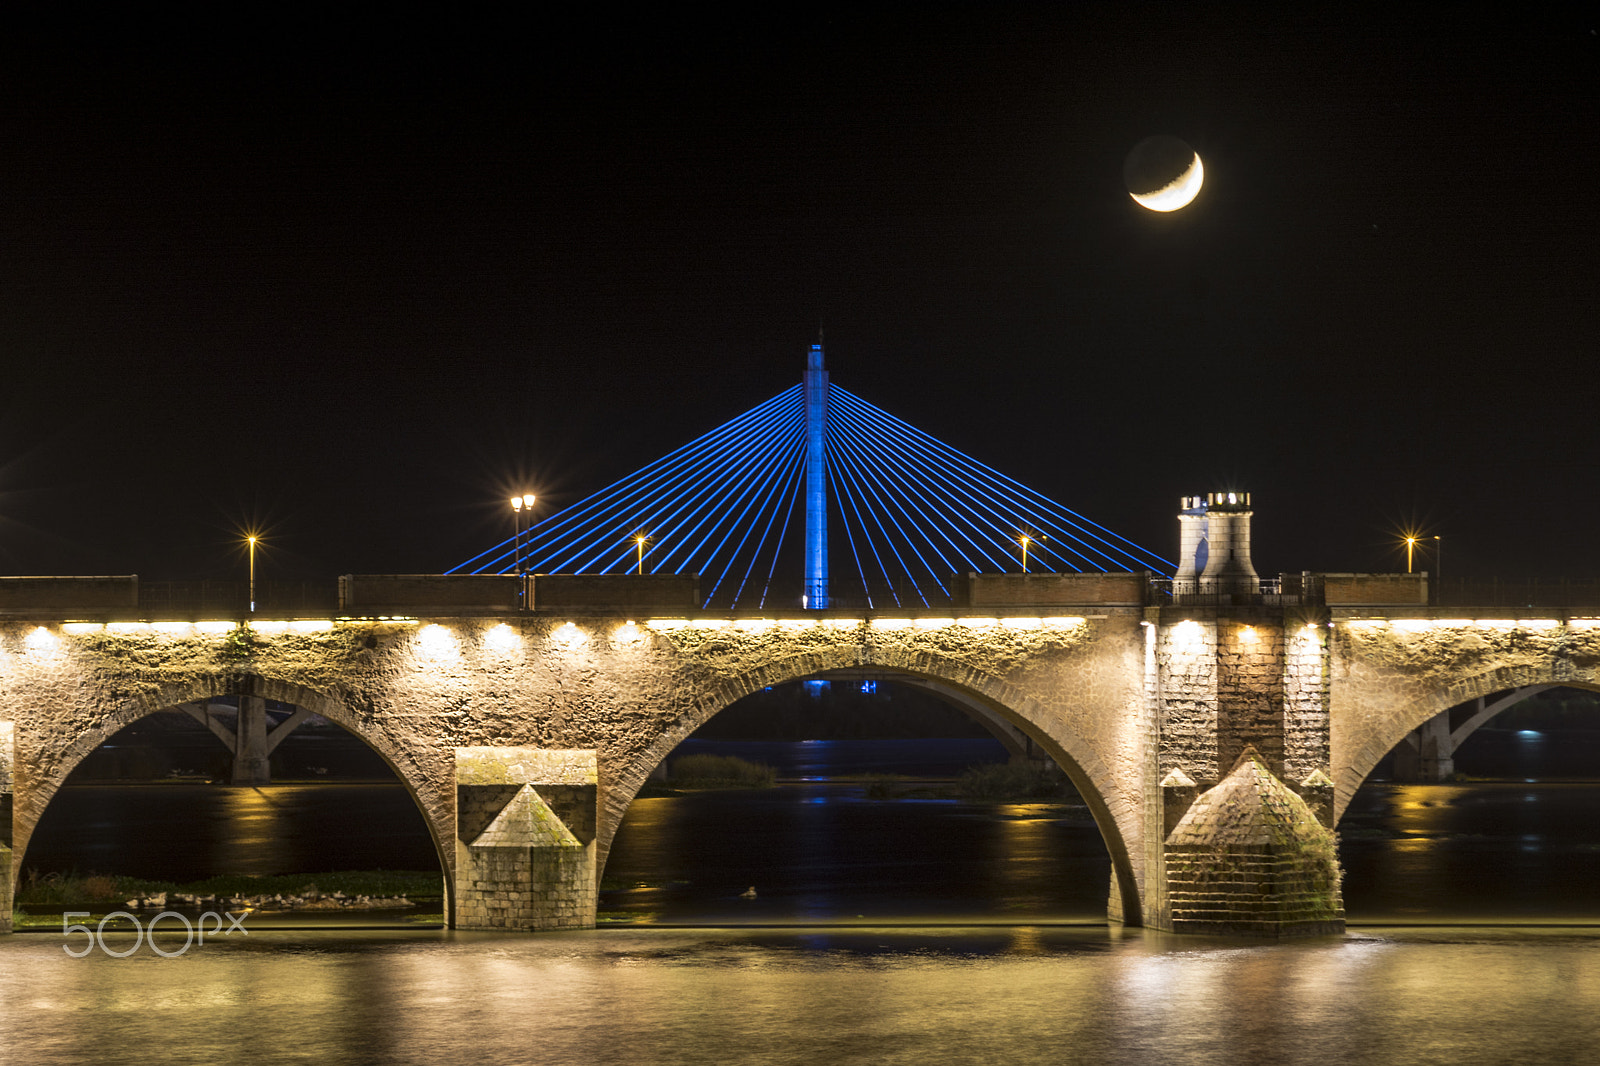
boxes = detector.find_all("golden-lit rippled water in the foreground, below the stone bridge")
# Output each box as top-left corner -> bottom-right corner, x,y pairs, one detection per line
0,927 -> 1600,1066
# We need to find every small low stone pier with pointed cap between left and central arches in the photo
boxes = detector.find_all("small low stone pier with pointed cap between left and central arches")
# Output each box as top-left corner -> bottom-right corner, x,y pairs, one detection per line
454,747 -> 600,932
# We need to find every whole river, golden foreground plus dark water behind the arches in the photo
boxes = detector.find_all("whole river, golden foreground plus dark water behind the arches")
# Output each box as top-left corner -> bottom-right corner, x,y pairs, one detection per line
9,735 -> 1600,1066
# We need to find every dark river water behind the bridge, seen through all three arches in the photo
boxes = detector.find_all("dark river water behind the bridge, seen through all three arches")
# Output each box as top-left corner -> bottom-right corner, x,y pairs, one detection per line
24,730 -> 1600,924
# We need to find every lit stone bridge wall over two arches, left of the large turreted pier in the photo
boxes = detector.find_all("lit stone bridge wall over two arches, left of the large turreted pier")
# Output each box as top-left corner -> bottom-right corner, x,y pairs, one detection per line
0,607 -> 1150,920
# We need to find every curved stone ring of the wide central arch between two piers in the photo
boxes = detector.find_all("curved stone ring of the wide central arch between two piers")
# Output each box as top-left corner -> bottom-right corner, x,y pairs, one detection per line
597,647 -> 1142,925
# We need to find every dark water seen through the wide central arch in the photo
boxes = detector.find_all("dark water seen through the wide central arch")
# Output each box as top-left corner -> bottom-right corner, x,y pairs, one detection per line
600,783 -> 1110,925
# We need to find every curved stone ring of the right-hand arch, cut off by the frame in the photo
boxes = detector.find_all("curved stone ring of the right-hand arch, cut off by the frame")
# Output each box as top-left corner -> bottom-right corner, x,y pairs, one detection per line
1334,659 -> 1600,824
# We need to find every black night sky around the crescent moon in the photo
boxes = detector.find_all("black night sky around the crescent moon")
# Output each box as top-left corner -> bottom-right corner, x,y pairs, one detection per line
0,3 -> 1600,579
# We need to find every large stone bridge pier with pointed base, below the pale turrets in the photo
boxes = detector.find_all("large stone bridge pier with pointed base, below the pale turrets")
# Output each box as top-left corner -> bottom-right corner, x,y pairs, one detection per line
1146,595 -> 1344,936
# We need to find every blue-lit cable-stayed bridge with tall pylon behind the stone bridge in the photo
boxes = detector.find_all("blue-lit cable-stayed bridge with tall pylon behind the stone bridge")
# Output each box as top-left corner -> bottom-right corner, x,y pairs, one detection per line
450,344 -> 1176,608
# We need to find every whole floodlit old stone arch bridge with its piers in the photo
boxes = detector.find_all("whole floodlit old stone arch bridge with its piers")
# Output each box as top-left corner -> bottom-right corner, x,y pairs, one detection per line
0,575 -> 1600,935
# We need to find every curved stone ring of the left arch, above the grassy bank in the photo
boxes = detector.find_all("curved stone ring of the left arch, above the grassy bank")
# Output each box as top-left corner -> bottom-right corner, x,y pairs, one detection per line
13,671 -> 456,916
